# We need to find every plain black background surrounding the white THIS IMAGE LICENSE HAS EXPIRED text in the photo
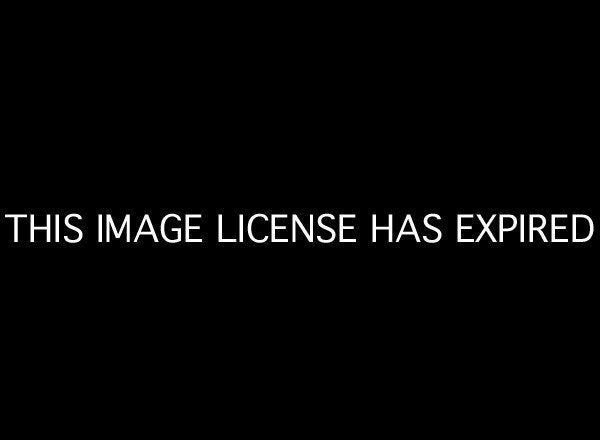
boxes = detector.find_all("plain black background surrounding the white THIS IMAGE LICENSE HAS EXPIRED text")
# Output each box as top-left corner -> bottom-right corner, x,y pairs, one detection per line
1,5 -> 598,433
